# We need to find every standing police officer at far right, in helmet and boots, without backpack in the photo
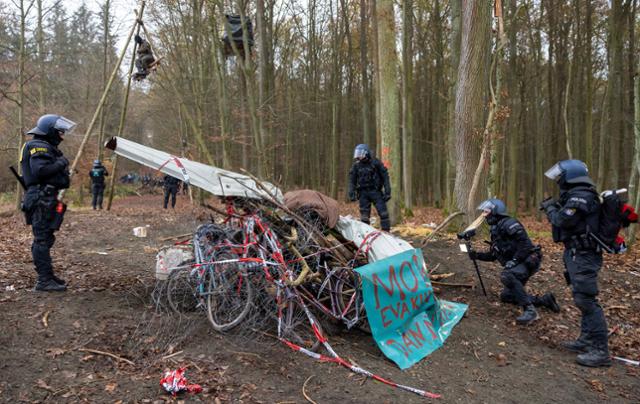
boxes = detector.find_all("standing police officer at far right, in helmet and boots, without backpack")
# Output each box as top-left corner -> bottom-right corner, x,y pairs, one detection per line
540,160 -> 611,367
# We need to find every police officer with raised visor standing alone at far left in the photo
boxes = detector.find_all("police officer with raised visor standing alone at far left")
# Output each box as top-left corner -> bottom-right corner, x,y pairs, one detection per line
20,114 -> 76,292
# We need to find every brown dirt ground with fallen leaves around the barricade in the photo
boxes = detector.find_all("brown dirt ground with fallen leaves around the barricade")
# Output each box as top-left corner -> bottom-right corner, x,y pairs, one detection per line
0,196 -> 640,403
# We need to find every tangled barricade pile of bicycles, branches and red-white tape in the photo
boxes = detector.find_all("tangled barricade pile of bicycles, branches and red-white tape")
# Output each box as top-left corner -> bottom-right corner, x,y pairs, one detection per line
151,181 -> 437,397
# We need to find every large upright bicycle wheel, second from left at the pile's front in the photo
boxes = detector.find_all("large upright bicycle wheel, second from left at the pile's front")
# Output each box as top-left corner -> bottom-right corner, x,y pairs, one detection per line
206,252 -> 253,331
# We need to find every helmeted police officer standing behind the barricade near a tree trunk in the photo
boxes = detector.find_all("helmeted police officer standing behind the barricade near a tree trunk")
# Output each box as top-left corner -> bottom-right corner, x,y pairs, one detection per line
349,144 -> 391,231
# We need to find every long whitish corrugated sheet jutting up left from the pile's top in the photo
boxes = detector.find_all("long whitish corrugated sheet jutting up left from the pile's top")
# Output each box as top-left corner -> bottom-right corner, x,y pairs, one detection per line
107,137 -> 284,203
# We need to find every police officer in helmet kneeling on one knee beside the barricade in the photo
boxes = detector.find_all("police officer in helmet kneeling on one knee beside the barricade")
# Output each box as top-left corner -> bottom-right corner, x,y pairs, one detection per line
469,199 -> 560,325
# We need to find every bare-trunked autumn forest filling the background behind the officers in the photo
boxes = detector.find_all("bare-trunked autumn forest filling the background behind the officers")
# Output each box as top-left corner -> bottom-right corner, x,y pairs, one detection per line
0,0 -> 640,230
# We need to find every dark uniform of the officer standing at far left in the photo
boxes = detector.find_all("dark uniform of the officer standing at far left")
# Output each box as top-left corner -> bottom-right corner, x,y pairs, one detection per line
20,136 -> 70,284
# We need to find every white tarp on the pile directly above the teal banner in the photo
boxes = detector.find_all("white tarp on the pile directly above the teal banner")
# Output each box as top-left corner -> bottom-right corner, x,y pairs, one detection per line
336,216 -> 413,262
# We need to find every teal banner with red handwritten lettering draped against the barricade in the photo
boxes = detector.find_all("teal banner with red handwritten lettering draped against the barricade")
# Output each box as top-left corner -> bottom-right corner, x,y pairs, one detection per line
356,249 -> 467,369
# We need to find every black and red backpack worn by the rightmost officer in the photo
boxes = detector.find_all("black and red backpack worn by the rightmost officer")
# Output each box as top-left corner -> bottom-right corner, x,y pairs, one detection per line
598,188 -> 638,254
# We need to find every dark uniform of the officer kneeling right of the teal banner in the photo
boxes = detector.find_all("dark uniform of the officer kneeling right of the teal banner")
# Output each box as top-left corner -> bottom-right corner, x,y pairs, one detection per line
476,216 -> 547,307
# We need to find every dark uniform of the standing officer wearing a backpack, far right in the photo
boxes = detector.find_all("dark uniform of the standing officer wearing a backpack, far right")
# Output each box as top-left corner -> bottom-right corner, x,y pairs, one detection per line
546,185 -> 609,352
